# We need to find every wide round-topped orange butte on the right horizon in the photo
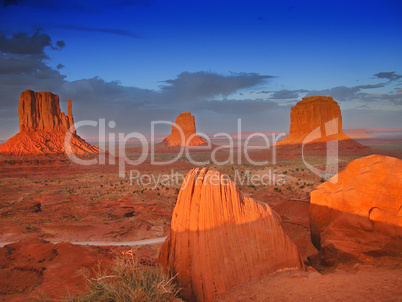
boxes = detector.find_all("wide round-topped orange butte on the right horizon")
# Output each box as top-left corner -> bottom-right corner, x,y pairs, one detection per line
277,96 -> 360,145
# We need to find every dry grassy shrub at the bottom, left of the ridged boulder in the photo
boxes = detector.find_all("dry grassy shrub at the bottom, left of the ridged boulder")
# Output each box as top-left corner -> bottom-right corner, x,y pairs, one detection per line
68,254 -> 180,302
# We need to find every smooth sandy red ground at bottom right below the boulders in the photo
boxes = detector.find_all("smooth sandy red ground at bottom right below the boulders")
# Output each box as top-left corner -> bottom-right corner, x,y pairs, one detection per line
215,265 -> 402,302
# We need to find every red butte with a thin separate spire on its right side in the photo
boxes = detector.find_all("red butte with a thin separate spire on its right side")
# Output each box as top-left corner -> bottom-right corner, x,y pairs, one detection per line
0,90 -> 99,155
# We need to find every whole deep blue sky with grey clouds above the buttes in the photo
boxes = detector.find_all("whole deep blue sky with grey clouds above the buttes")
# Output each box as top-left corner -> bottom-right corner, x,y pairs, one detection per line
0,0 -> 402,139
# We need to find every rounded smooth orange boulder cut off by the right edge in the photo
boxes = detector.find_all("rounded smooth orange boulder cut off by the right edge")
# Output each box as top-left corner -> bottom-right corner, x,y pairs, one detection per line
310,155 -> 402,265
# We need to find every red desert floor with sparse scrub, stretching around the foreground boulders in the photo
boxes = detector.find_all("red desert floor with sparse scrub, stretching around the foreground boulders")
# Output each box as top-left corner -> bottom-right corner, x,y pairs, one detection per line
0,141 -> 402,301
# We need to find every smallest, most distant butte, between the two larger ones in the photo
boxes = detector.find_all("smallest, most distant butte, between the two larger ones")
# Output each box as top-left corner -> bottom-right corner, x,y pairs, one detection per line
163,112 -> 207,147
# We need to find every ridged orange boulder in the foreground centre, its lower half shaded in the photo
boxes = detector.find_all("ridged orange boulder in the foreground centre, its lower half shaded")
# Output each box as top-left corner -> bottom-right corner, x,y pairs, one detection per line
159,168 -> 303,301
